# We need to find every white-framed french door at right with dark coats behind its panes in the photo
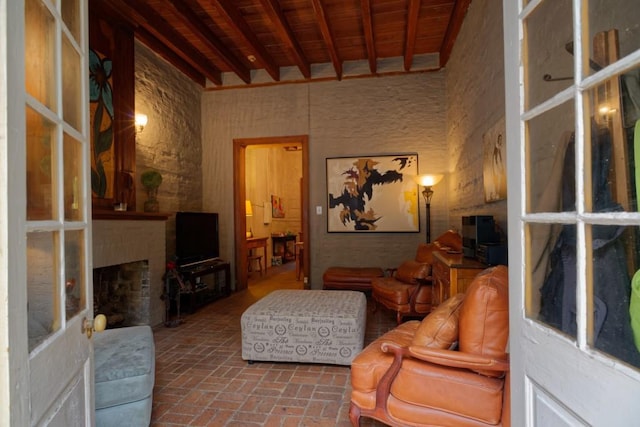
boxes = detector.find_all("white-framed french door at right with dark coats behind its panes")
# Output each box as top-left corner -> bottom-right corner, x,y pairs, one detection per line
503,0 -> 640,426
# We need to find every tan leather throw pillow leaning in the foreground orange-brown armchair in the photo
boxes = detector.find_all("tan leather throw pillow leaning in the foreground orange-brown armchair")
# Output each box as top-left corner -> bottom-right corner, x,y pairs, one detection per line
412,294 -> 464,349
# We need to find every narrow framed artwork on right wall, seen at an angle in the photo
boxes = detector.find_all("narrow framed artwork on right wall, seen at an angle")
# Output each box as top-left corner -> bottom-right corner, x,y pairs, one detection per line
482,117 -> 507,202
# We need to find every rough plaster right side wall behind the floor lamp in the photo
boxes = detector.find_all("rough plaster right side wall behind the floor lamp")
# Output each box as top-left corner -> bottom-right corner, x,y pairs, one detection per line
448,0 -> 509,237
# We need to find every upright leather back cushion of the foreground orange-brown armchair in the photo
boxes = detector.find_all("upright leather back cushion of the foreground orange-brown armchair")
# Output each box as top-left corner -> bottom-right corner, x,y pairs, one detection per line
459,265 -> 509,376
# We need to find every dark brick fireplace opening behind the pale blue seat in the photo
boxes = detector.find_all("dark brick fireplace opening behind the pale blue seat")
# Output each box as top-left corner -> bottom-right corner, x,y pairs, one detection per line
93,260 -> 150,328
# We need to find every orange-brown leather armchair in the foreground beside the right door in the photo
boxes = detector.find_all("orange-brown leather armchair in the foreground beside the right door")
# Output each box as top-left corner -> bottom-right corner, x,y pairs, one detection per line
349,266 -> 510,427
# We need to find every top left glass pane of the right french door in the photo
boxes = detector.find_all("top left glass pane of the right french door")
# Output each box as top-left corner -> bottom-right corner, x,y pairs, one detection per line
524,0 -> 573,110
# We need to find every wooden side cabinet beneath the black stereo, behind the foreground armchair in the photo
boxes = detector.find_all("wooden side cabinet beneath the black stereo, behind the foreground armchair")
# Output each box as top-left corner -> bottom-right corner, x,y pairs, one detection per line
431,251 -> 488,308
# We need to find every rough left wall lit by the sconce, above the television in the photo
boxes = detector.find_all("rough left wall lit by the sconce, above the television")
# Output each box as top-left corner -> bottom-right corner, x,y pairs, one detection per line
135,42 -> 202,259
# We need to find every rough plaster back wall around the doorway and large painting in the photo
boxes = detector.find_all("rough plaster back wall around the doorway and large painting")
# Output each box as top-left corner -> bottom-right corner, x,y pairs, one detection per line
202,73 -> 449,288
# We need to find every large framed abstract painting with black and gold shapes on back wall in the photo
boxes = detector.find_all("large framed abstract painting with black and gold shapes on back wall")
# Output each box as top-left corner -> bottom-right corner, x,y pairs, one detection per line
327,153 -> 420,233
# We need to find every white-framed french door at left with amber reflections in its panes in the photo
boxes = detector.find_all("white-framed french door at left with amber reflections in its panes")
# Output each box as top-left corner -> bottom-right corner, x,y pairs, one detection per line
0,0 -> 93,426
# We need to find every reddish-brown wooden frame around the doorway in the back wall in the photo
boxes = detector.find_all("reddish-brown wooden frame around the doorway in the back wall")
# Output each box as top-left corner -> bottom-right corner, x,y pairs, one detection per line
233,135 -> 311,291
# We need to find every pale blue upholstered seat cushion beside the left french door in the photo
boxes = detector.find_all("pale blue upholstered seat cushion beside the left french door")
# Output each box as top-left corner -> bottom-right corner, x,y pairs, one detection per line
94,326 -> 155,409
